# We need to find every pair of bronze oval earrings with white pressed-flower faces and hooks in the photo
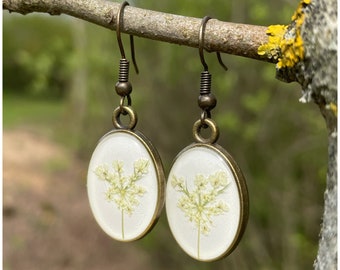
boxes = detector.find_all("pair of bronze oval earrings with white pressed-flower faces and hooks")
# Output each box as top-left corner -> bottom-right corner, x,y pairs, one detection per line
87,2 -> 248,261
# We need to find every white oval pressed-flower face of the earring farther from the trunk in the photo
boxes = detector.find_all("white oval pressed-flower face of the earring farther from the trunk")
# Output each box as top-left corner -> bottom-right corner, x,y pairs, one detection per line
87,130 -> 163,241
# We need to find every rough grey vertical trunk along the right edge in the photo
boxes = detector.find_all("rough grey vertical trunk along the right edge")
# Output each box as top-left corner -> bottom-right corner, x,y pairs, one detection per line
297,0 -> 338,270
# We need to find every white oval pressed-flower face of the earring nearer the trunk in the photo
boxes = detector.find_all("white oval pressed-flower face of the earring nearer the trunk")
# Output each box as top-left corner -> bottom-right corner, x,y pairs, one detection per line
166,145 -> 242,261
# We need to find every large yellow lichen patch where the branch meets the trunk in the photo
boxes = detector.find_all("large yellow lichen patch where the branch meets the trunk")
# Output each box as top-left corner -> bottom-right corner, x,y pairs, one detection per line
258,0 -> 311,69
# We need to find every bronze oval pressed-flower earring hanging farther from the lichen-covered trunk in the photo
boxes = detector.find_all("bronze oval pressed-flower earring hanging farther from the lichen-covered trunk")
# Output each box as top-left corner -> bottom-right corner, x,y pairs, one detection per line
87,2 -> 165,242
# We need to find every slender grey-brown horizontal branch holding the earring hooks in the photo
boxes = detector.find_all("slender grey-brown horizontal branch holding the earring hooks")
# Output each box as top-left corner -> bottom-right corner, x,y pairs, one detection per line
3,0 -> 275,62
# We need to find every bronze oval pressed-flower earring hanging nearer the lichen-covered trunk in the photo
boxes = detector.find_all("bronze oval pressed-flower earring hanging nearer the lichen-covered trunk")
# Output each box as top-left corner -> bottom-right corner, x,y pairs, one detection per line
165,17 -> 249,261
